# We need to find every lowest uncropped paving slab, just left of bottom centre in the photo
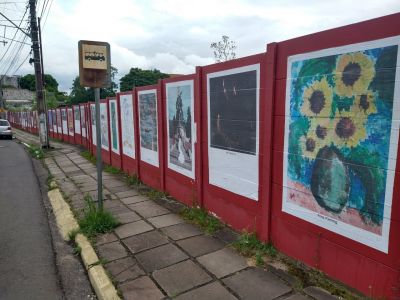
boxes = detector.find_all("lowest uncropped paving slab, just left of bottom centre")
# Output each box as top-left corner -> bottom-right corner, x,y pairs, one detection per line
153,260 -> 212,296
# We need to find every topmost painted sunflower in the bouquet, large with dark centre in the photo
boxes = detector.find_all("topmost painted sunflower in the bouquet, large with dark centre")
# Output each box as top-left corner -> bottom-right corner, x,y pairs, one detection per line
335,52 -> 375,97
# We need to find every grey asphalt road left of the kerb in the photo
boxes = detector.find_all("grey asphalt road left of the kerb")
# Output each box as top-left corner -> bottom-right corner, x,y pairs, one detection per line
0,140 -> 63,299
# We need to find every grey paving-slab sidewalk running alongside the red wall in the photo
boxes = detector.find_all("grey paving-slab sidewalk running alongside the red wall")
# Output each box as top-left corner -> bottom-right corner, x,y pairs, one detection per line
15,130 -> 336,300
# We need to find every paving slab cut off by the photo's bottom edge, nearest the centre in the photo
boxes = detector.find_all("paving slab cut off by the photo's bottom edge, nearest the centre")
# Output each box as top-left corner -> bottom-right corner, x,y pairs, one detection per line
174,282 -> 237,300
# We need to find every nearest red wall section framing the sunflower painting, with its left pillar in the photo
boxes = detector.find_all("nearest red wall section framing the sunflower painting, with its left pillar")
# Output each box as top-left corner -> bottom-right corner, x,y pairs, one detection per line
268,14 -> 400,299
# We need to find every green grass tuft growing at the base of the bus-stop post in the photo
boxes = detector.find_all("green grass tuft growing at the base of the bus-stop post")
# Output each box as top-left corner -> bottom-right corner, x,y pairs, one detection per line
78,195 -> 119,238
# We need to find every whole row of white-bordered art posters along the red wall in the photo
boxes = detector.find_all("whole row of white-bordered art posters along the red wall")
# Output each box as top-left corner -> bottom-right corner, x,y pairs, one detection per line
46,37 -> 400,253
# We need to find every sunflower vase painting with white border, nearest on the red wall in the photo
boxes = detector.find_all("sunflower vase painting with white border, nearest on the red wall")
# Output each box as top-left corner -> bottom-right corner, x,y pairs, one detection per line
282,37 -> 400,252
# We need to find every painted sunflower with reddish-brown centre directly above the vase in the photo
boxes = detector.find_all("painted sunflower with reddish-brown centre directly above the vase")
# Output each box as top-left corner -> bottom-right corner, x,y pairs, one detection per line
332,109 -> 367,148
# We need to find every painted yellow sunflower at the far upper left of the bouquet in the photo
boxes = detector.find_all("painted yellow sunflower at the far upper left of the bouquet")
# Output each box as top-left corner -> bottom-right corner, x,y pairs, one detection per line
301,77 -> 333,117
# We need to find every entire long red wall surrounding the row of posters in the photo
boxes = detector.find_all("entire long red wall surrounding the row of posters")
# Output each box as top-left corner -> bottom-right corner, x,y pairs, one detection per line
11,14 -> 400,299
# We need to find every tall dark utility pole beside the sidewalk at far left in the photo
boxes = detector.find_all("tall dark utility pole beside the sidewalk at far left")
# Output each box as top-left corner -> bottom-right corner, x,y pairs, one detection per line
29,0 -> 49,148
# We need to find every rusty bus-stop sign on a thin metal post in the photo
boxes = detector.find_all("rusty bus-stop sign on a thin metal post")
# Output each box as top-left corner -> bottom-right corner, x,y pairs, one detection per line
78,41 -> 111,209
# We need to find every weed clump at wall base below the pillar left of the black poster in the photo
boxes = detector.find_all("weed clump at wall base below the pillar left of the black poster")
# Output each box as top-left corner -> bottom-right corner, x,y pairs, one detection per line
180,207 -> 222,234
